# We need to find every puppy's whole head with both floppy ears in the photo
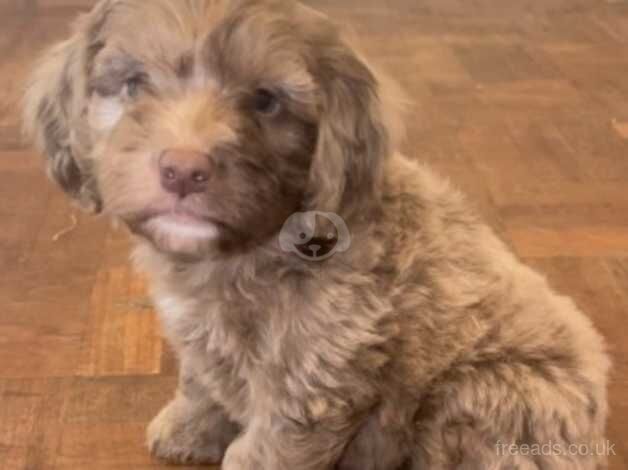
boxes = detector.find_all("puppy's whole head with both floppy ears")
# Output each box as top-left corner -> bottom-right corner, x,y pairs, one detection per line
25,0 -> 402,255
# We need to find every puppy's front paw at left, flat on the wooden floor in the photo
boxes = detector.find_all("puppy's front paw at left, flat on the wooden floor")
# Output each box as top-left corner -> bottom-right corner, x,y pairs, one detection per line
147,401 -> 233,464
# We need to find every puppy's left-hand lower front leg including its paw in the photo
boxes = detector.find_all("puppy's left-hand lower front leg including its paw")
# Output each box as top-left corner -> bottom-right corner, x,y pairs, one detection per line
147,372 -> 240,464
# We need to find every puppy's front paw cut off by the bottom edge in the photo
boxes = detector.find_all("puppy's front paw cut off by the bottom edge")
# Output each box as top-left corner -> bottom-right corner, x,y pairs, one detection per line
222,416 -> 355,470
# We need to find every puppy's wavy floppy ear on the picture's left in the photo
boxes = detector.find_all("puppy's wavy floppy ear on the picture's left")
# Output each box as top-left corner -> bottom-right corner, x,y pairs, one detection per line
23,0 -> 115,213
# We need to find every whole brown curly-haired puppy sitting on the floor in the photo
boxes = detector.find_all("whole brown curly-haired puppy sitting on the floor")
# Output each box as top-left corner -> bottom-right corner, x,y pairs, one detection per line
25,0 -> 609,470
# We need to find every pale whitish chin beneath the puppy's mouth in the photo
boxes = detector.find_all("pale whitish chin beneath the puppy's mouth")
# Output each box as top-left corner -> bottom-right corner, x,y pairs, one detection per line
129,213 -> 225,257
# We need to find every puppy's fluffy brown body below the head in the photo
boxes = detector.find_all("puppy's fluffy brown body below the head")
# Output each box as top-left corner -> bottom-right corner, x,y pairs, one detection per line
136,156 -> 608,470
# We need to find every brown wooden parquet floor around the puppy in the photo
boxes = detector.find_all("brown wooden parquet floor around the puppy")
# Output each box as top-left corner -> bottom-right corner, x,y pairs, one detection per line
0,0 -> 628,470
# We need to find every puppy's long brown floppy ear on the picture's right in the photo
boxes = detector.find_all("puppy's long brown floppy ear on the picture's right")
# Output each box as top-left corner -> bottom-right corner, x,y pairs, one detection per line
308,33 -> 402,217
